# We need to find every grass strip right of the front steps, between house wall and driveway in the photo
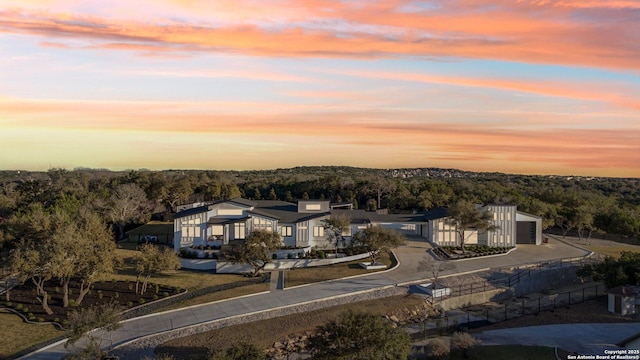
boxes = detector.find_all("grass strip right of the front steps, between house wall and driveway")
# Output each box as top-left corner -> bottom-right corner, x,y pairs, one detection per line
284,254 -> 396,288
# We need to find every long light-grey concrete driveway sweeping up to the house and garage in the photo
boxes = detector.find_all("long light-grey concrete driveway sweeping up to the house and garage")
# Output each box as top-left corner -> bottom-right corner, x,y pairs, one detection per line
23,238 -> 588,359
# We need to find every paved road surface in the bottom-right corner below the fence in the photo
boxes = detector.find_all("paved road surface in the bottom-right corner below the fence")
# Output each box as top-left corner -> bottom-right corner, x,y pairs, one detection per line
475,323 -> 640,355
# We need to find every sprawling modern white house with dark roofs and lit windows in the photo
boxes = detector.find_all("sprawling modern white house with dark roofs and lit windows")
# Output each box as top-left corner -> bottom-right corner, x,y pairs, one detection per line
173,198 -> 542,252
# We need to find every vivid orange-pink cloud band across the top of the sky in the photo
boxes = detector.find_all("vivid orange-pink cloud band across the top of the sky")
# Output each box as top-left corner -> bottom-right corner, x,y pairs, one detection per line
0,0 -> 640,69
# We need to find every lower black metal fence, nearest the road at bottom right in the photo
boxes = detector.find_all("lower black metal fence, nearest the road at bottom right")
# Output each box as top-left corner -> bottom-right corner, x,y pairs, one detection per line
411,284 -> 606,340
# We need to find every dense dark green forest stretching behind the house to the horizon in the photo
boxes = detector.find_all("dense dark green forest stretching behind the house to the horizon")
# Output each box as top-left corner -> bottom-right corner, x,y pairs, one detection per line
0,167 -> 640,250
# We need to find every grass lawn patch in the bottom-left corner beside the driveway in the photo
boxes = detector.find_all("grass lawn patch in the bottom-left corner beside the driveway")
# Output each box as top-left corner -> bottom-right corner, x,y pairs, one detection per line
0,310 -> 64,359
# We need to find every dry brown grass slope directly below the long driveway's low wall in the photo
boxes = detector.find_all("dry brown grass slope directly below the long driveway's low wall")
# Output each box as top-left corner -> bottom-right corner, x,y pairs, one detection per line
156,296 -> 424,359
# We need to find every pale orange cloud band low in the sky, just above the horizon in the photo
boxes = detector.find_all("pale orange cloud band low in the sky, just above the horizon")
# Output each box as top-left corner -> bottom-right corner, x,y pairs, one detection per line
0,98 -> 640,176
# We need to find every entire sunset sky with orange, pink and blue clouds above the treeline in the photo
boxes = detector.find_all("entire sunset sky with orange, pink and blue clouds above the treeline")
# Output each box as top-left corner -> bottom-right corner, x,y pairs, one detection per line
0,0 -> 640,177
